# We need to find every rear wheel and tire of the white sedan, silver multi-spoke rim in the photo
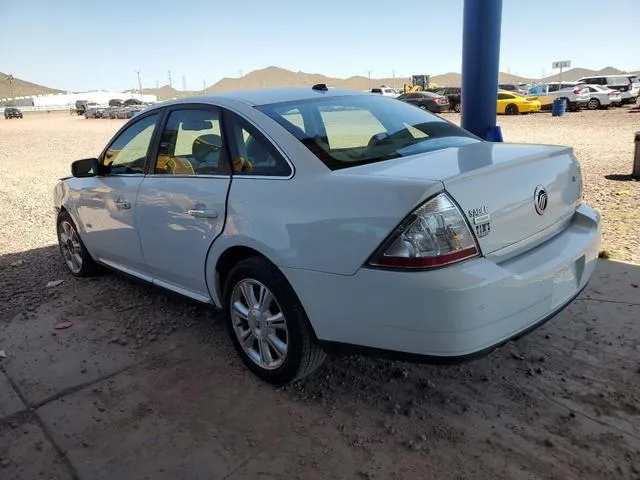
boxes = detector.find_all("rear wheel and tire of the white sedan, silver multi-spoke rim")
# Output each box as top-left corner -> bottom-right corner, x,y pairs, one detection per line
223,257 -> 326,385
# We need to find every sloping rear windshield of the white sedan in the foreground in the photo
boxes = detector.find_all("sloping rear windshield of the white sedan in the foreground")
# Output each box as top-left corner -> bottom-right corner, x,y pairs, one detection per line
257,95 -> 480,170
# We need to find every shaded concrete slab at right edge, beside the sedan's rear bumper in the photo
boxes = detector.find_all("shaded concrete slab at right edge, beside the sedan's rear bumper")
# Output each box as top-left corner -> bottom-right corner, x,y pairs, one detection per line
583,260 -> 640,304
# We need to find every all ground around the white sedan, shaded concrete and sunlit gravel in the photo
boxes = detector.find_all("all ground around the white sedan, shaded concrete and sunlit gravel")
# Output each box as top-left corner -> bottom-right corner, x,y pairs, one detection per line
0,109 -> 640,480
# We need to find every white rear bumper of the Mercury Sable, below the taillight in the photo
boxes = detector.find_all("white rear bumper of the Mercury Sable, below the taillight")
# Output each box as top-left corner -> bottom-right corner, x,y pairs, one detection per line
282,205 -> 600,361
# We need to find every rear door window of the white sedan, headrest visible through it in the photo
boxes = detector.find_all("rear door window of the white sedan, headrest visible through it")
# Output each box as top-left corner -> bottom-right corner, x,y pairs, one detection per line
153,109 -> 229,175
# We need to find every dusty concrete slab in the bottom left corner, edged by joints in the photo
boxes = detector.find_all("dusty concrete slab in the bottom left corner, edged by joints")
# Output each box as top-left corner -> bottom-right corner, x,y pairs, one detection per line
0,414 -> 73,480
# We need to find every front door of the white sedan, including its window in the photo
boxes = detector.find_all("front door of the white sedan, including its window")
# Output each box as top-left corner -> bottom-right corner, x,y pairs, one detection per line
77,113 -> 160,276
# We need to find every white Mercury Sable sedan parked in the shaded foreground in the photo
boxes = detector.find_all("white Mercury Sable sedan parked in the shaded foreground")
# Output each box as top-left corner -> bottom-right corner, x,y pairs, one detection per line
54,84 -> 600,384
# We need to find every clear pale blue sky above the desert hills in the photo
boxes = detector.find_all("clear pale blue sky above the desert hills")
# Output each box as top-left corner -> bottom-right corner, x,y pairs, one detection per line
0,0 -> 640,91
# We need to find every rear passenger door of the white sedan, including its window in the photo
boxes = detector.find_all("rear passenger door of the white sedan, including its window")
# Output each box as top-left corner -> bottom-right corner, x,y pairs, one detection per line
137,105 -> 231,301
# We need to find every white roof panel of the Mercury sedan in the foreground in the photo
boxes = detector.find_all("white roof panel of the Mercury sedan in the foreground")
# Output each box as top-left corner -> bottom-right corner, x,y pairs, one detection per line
148,86 -> 362,107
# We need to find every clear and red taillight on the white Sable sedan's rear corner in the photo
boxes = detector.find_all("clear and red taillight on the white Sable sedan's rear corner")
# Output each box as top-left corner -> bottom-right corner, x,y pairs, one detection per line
367,193 -> 480,269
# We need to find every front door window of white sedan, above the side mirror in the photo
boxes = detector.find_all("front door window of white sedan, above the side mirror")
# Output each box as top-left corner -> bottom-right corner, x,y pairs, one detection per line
102,113 -> 158,175
